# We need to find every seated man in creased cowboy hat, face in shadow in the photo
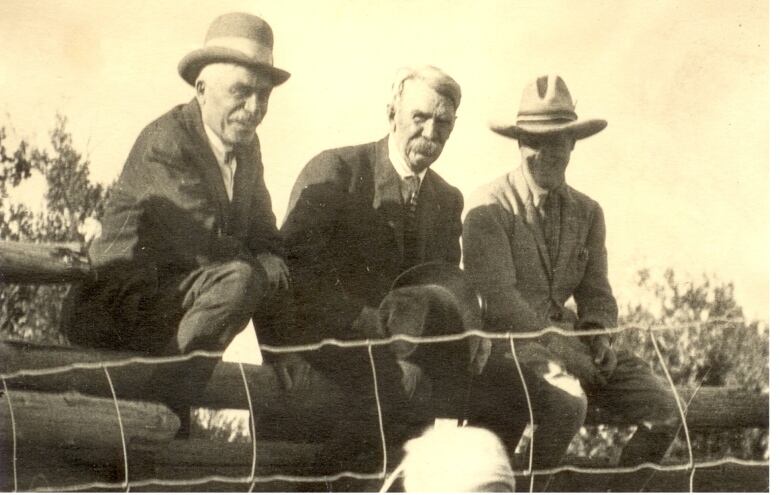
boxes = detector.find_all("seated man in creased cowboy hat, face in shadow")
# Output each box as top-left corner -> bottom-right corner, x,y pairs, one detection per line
463,75 -> 677,484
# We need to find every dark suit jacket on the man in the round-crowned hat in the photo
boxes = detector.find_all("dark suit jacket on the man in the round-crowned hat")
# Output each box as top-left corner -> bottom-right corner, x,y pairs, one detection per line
66,99 -> 283,348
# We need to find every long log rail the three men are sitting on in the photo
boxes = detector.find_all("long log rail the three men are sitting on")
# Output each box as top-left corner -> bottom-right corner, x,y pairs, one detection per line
0,341 -> 769,431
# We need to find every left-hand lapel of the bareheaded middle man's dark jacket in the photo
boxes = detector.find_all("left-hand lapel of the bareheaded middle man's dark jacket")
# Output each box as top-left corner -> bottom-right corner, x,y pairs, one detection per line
374,137 -> 404,253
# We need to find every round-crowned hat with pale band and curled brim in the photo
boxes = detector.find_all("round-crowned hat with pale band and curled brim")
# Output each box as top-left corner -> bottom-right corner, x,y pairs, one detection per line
179,12 -> 290,86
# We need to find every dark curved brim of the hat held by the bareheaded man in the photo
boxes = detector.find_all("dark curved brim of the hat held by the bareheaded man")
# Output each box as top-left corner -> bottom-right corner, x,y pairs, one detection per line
392,261 -> 482,329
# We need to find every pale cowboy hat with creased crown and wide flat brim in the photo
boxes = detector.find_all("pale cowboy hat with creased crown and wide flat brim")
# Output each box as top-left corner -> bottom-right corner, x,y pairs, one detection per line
490,74 -> 607,140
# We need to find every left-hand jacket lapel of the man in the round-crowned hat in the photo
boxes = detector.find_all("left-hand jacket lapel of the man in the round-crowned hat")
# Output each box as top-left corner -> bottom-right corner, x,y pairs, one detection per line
184,99 -> 230,228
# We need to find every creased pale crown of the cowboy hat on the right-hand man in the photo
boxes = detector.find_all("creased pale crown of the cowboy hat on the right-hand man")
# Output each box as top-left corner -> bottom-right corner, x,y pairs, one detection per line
517,74 -> 577,123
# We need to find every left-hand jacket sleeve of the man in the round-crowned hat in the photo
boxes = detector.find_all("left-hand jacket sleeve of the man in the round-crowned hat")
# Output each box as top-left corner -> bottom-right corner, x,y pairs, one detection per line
90,129 -> 249,269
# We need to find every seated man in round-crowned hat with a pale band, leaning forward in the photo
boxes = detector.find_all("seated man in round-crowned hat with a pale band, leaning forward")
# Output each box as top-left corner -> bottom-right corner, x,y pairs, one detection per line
68,9 -> 290,429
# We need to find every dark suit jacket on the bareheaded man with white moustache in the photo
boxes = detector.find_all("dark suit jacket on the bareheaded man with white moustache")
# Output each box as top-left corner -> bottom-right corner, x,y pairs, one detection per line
282,138 -> 463,342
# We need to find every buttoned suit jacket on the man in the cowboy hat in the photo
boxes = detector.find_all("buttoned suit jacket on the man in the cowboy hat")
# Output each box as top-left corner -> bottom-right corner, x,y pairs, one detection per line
463,169 -> 617,331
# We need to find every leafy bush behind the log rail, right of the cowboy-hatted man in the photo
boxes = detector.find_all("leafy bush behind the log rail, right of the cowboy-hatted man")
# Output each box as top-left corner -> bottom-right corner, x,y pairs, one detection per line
570,269 -> 769,460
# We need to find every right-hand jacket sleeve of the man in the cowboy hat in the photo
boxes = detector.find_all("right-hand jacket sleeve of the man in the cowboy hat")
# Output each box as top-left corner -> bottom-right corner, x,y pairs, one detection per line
574,205 -> 618,329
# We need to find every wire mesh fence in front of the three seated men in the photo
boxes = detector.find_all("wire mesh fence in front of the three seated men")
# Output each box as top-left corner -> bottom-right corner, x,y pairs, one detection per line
0,318 -> 769,492
